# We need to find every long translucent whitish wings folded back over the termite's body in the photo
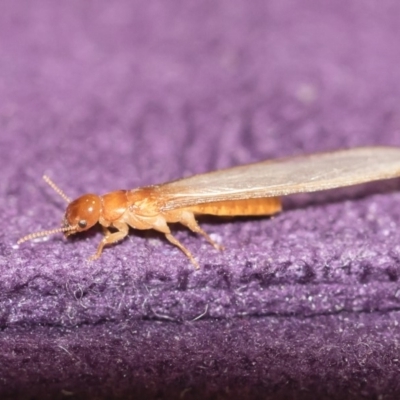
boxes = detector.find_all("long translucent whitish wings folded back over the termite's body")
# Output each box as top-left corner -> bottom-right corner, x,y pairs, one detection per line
154,147 -> 400,210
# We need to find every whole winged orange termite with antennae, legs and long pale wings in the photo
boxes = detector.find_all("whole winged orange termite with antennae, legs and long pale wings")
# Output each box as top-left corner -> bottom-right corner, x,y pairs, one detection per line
18,147 -> 400,268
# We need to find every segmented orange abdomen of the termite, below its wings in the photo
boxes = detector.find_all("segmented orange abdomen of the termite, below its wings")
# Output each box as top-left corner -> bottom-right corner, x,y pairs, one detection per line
188,197 -> 282,216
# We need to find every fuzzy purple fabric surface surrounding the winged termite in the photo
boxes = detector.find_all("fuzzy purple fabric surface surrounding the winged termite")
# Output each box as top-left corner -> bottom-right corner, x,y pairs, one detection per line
0,0 -> 400,399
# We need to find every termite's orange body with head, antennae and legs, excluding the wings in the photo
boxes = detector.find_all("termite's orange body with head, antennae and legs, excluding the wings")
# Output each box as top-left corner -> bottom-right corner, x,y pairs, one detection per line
19,182 -> 281,268
